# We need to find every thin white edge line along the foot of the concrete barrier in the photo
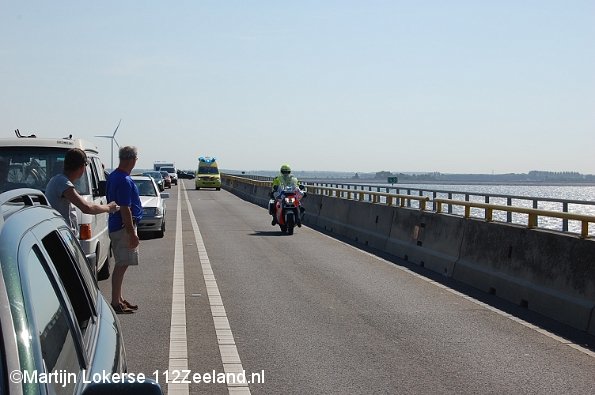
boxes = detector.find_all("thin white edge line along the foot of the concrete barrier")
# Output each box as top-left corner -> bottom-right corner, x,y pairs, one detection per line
311,228 -> 595,358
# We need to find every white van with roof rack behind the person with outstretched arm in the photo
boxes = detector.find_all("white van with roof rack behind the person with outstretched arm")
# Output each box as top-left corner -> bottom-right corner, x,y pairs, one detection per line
0,131 -> 111,280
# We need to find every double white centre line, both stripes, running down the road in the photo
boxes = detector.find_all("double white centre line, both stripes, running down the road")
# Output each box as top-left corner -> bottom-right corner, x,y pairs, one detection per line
168,183 -> 250,395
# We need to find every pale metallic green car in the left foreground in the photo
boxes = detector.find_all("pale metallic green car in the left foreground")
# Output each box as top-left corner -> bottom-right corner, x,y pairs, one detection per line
0,189 -> 162,395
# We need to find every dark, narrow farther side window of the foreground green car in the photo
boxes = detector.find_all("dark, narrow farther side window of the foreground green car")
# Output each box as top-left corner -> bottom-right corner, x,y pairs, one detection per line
42,231 -> 94,334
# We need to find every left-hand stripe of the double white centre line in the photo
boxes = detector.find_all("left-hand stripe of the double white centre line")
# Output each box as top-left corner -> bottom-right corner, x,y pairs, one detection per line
167,184 -> 190,395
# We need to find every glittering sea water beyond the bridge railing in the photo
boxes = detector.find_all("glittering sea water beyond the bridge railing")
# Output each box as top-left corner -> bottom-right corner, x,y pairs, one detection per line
338,184 -> 595,236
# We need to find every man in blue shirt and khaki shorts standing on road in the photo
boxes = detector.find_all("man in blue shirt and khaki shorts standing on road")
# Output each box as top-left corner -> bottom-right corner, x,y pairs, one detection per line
107,146 -> 143,314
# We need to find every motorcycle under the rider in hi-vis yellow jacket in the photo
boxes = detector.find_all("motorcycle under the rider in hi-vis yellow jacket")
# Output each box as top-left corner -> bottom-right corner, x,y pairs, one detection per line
269,185 -> 306,235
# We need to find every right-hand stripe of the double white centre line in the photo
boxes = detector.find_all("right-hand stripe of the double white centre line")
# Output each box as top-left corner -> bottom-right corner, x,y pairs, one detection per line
180,183 -> 250,394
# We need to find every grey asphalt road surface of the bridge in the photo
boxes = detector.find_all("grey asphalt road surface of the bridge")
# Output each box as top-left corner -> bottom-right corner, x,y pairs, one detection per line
100,180 -> 595,394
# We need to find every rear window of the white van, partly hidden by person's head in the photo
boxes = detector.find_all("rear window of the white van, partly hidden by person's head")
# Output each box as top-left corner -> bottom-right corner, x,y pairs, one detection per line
0,147 -> 90,195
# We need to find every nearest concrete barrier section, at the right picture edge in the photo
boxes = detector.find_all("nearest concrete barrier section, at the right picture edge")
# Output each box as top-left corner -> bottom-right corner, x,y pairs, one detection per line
453,219 -> 595,334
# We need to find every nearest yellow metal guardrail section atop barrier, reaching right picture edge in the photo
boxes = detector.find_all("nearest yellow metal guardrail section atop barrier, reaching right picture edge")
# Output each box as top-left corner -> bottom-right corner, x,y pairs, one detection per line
434,199 -> 595,239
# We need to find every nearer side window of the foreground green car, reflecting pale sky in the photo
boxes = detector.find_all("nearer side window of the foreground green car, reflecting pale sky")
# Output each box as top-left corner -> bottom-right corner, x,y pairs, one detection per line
25,247 -> 82,394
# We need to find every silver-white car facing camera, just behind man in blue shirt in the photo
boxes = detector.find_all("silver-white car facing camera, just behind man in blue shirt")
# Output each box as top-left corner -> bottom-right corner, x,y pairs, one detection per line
130,176 -> 169,237
